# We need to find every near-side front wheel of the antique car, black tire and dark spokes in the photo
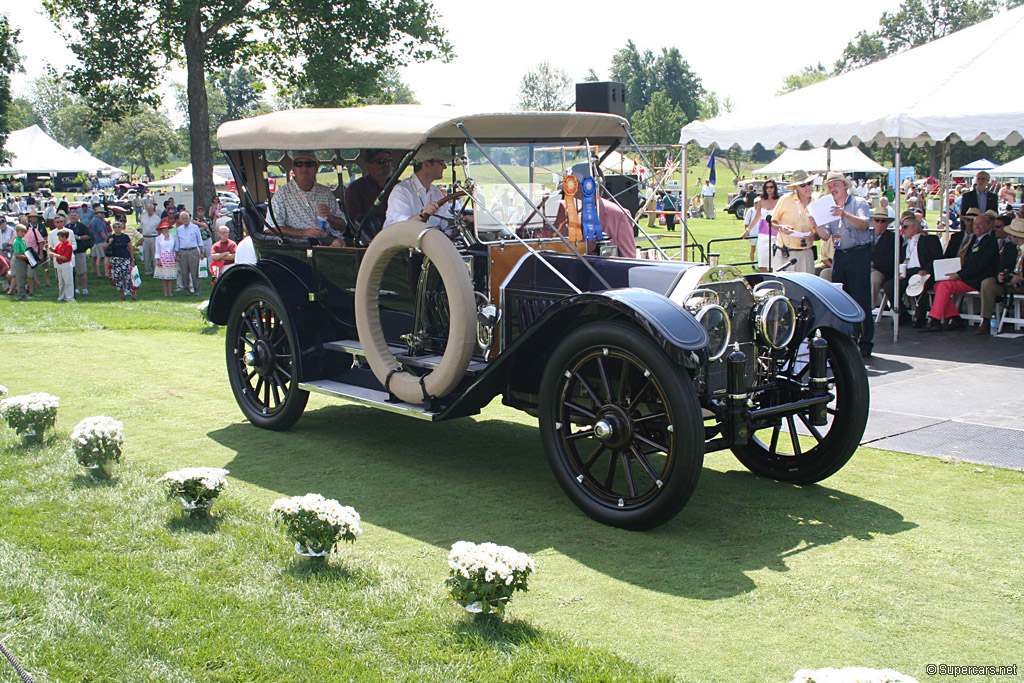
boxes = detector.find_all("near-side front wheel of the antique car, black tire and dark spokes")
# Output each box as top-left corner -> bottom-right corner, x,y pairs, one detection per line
540,323 -> 703,530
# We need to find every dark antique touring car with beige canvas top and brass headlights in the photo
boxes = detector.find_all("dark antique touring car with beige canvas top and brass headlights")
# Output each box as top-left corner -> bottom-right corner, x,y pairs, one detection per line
209,105 -> 868,529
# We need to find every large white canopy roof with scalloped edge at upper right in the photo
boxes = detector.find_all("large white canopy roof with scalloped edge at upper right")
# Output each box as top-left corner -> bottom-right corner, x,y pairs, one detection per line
680,6 -> 1024,150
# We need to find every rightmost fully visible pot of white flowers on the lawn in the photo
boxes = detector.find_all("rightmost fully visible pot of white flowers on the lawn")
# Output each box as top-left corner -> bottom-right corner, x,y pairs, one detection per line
445,541 -> 537,614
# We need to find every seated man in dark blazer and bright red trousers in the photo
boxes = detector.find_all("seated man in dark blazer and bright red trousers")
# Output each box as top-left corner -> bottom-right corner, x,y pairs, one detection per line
924,213 -> 999,332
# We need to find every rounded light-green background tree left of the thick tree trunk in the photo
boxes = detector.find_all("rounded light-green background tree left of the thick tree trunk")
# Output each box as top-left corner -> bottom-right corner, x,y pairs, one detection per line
93,110 -> 177,179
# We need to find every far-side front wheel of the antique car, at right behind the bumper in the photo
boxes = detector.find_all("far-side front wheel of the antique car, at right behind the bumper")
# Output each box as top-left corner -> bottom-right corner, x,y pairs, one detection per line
732,329 -> 870,484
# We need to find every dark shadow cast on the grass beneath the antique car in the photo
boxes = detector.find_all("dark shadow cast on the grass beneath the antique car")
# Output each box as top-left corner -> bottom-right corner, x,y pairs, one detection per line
209,404 -> 916,600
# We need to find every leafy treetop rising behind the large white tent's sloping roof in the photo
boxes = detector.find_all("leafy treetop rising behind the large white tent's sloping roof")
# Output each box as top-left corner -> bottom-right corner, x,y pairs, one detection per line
836,0 -> 999,73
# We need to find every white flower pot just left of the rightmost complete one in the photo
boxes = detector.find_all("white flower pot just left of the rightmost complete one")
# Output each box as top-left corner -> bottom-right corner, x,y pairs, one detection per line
270,494 -> 362,556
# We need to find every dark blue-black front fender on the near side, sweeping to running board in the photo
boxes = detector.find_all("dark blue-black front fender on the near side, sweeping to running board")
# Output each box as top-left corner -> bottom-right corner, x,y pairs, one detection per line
440,288 -> 711,419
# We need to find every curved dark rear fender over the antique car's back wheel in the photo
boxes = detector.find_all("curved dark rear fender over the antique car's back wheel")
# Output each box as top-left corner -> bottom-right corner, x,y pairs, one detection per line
208,259 -> 327,380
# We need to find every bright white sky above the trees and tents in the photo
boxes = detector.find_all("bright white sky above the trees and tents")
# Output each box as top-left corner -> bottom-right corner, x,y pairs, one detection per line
9,0 -> 898,115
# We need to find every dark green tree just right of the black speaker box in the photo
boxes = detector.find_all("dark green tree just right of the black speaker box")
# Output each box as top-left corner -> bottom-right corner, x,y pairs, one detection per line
611,40 -> 705,125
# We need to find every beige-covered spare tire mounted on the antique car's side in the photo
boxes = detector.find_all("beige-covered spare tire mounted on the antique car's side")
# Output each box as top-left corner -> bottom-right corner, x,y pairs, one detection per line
355,220 -> 476,403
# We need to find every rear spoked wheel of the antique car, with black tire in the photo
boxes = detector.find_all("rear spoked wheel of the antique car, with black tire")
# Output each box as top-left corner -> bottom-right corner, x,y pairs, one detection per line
225,284 -> 309,431
